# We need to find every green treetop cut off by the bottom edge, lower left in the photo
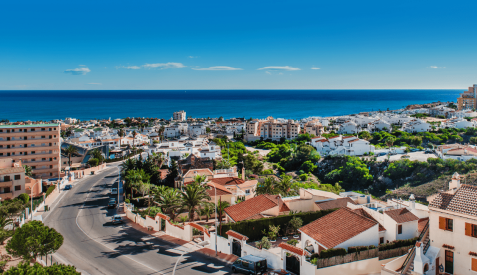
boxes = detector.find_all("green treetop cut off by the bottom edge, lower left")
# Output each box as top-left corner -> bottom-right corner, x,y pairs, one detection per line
3,262 -> 81,275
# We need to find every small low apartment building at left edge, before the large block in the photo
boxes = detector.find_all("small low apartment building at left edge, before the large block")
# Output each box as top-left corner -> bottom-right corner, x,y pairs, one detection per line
0,158 -> 25,200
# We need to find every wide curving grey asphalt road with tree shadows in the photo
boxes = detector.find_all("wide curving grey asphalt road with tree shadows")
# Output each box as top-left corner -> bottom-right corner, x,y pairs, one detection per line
43,167 -> 230,275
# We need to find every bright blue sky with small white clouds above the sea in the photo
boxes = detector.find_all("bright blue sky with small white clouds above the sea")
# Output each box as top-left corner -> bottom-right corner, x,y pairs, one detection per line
0,0 -> 477,90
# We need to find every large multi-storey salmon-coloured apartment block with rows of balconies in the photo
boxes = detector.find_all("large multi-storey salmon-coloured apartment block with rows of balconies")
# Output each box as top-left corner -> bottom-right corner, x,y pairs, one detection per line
0,124 -> 61,179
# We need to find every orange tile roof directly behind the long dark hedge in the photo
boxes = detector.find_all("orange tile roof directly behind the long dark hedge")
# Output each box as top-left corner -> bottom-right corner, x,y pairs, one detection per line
225,195 -> 290,222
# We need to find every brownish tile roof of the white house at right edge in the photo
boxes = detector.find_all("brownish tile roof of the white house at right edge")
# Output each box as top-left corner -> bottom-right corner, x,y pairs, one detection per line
429,184 -> 477,216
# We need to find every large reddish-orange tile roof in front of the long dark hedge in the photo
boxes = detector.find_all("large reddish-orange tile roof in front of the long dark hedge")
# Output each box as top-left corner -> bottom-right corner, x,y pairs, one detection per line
298,208 -> 378,248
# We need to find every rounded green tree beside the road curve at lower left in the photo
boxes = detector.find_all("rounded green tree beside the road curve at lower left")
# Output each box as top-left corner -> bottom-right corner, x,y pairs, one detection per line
6,221 -> 63,261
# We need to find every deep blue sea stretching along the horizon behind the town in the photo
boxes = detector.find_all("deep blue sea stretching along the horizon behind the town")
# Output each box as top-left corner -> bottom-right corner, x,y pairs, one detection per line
0,89 -> 463,121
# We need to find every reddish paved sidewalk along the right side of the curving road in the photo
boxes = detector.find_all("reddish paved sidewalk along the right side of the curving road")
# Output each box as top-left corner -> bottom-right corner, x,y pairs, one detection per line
121,218 -> 239,264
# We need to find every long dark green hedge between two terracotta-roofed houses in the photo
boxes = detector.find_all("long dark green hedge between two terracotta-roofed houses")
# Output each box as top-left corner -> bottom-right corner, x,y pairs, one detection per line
220,209 -> 337,241
